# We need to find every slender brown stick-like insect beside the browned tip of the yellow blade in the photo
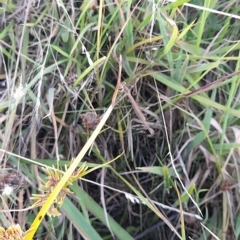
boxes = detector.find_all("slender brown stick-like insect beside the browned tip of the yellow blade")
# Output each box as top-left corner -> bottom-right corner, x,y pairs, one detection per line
119,83 -> 154,135
